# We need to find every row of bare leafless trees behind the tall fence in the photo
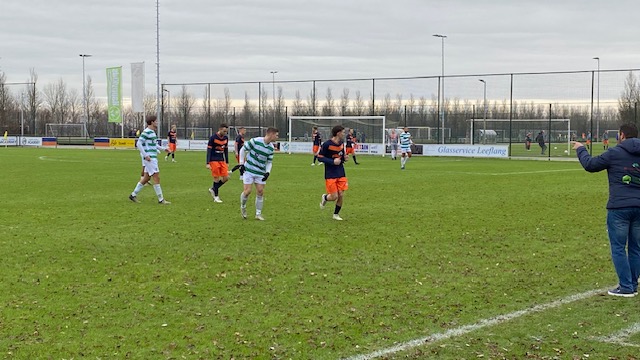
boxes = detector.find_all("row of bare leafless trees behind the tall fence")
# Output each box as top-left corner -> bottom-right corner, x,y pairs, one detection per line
0,69 -> 640,137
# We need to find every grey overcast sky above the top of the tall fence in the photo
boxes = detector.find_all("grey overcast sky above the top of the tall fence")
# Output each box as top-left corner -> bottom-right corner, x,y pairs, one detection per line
0,0 -> 640,101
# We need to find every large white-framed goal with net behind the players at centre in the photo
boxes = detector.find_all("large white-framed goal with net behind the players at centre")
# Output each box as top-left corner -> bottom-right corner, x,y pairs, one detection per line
288,116 -> 386,156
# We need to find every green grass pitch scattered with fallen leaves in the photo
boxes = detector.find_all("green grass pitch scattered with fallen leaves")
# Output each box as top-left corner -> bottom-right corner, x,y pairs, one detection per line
0,148 -> 640,359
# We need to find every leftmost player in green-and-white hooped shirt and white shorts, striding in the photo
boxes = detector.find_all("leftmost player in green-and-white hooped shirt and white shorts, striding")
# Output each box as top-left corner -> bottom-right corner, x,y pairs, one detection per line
129,115 -> 171,205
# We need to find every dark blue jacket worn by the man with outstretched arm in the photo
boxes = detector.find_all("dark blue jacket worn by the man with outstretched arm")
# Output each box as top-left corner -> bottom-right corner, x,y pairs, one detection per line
577,138 -> 640,209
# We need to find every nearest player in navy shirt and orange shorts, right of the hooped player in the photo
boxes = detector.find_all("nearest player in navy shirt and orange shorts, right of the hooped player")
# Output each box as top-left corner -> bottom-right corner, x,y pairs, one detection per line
318,125 -> 349,221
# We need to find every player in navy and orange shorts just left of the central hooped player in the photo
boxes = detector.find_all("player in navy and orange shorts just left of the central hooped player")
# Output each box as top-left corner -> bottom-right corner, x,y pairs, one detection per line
207,124 -> 229,203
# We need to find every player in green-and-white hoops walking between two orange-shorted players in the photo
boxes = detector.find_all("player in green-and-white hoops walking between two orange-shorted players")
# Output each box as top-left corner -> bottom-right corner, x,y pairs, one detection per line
233,127 -> 278,221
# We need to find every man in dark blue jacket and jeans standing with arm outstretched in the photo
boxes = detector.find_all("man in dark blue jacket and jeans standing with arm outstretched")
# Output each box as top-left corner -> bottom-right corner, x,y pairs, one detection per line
573,124 -> 640,297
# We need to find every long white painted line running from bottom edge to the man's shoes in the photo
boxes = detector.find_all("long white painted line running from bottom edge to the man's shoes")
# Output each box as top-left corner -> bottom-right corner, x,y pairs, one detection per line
346,288 -> 607,360
